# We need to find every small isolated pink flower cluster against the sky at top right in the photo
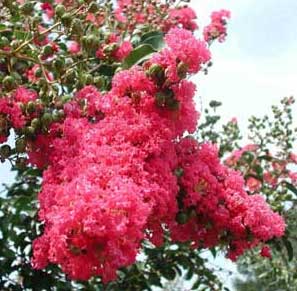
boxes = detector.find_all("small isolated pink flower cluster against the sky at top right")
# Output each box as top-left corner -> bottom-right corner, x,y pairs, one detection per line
203,10 -> 230,42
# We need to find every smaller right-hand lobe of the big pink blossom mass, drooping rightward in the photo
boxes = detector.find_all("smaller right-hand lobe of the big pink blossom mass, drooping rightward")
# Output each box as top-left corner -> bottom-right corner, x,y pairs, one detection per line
171,138 -> 285,260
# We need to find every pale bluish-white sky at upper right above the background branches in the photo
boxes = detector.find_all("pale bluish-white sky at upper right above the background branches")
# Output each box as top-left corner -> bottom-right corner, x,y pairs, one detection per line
192,0 -> 297,129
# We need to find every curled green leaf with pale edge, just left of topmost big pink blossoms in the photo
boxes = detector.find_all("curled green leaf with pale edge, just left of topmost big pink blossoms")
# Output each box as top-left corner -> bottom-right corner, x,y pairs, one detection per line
123,44 -> 156,69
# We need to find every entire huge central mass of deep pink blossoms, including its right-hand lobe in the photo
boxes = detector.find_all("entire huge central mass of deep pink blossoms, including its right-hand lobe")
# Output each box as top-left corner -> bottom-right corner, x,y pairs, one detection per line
29,29 -> 285,282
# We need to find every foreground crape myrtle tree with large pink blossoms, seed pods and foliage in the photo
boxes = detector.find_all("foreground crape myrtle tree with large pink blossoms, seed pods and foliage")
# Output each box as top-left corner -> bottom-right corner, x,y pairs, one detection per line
0,0 -> 286,290
